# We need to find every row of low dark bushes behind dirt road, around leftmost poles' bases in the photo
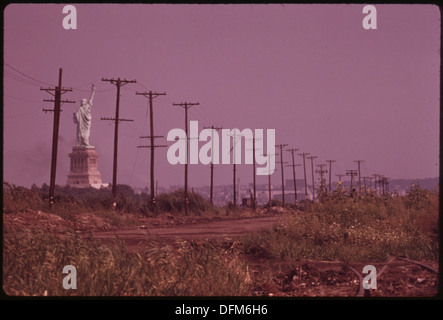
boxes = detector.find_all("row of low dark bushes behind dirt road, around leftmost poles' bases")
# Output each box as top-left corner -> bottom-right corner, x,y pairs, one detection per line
3,182 -> 221,218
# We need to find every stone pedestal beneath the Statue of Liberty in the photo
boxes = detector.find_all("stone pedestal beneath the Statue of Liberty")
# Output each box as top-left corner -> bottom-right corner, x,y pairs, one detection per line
67,146 -> 108,188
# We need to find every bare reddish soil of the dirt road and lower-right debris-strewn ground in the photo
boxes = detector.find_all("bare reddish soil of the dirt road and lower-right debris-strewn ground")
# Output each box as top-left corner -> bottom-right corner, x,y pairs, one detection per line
3,210 -> 439,297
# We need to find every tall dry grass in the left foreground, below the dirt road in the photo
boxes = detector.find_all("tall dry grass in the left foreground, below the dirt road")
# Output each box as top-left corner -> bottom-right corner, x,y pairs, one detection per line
3,226 -> 250,296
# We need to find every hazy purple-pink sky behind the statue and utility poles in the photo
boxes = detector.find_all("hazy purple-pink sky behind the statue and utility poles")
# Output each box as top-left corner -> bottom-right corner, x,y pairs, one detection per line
3,4 -> 440,187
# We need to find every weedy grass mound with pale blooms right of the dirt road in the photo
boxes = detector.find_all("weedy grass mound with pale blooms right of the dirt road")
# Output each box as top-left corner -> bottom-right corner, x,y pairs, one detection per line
244,193 -> 439,262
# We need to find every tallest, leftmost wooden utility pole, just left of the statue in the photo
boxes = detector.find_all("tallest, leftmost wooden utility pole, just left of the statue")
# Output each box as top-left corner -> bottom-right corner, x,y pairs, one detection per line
40,68 -> 75,208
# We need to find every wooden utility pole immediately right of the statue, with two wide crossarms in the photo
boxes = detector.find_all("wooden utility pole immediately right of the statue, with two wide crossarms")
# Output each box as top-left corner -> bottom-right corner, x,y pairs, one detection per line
100,78 -> 137,209
